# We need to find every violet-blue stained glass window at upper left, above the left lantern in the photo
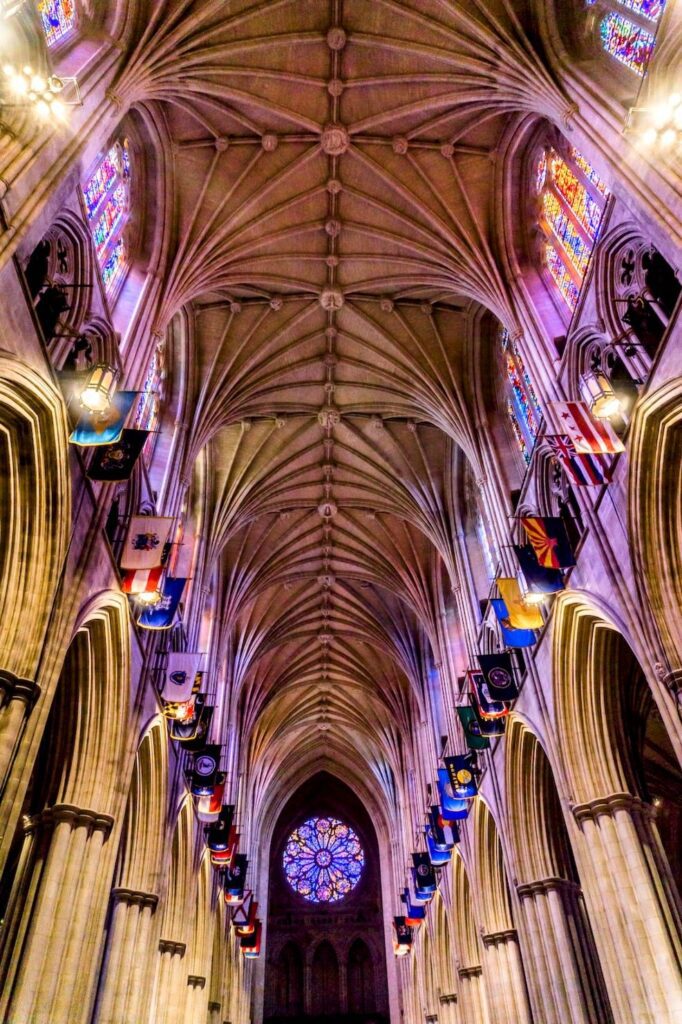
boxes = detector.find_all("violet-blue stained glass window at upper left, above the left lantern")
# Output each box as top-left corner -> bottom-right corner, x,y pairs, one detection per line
83,141 -> 131,294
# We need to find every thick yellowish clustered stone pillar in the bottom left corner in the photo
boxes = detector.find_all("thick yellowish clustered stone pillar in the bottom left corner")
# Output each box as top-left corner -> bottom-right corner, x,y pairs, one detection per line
7,804 -> 113,1024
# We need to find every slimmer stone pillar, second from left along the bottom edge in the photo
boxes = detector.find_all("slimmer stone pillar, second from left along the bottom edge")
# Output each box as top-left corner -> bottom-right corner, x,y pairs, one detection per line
94,889 -> 159,1024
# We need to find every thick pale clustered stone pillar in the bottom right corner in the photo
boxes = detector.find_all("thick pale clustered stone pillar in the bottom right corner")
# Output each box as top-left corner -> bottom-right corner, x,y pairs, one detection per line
572,794 -> 682,1024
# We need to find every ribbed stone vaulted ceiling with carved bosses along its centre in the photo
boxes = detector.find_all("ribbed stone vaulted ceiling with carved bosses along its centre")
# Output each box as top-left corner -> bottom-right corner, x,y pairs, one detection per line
120,0 -> 568,802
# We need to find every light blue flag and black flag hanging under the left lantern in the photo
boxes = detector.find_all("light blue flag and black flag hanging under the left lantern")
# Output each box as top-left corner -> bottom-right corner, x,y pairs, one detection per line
69,391 -> 152,482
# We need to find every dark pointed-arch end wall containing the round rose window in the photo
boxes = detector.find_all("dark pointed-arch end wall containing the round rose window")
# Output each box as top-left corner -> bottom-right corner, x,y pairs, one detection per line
264,772 -> 388,1024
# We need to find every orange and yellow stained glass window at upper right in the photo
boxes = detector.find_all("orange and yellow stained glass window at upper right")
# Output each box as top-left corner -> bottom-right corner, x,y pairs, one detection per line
535,146 -> 609,313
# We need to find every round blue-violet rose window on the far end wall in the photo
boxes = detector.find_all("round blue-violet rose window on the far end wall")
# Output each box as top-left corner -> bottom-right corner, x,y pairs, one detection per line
282,817 -> 365,903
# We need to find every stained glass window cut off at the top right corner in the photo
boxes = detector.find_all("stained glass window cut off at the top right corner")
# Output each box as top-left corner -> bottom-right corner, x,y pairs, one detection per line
586,0 -> 666,76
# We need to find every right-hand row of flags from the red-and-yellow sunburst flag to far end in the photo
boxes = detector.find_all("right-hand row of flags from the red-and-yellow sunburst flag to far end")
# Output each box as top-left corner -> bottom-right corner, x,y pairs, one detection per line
393,516 -> 576,956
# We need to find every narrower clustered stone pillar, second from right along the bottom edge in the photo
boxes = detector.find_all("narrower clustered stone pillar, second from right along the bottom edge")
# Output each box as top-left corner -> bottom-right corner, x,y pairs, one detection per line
517,878 -> 611,1024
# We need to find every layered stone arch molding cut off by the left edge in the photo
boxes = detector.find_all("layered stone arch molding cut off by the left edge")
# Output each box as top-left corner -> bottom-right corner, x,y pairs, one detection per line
0,354 -> 71,679
